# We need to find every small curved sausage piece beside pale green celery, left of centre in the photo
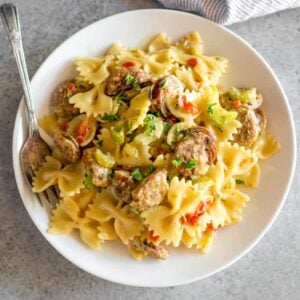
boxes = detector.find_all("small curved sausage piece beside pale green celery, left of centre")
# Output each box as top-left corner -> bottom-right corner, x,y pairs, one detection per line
82,148 -> 111,187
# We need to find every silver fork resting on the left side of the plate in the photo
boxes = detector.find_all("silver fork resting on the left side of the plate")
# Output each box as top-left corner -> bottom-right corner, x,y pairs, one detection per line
0,4 -> 59,212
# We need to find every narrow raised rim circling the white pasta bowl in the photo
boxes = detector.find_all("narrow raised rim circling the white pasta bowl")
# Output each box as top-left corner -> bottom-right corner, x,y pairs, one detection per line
12,8 -> 297,288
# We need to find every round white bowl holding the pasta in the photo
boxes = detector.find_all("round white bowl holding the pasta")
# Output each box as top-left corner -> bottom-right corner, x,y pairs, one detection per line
13,9 -> 296,287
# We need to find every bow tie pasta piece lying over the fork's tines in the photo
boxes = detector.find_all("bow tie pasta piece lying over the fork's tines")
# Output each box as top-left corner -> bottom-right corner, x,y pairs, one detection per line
32,156 -> 84,197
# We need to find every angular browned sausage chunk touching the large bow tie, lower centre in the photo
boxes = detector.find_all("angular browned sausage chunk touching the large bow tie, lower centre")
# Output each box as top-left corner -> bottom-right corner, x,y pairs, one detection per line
130,169 -> 169,211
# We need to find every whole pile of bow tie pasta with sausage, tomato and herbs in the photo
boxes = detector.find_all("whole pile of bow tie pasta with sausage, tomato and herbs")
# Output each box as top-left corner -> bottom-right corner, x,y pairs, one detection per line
33,32 -> 280,259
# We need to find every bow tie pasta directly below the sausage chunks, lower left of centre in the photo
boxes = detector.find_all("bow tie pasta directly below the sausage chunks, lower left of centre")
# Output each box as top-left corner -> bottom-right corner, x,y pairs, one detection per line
86,190 -> 144,245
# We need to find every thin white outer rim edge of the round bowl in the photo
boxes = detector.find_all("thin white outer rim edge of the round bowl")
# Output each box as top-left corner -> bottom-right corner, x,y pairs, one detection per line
12,9 -> 297,288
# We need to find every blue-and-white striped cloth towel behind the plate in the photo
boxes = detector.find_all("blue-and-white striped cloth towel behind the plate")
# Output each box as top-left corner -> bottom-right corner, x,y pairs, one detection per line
159,0 -> 300,25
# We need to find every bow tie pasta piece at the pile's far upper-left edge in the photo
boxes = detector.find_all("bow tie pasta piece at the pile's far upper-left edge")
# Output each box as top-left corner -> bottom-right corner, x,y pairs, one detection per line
75,56 -> 113,85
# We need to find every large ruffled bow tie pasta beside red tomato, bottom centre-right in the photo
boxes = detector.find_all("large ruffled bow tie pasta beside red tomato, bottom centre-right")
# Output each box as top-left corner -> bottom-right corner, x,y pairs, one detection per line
141,177 -> 213,247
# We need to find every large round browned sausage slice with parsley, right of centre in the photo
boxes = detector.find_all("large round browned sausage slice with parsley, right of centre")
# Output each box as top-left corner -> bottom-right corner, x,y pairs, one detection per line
175,126 -> 217,177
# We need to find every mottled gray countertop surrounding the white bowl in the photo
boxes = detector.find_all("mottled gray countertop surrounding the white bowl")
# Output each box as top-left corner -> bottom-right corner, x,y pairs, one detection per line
0,0 -> 300,300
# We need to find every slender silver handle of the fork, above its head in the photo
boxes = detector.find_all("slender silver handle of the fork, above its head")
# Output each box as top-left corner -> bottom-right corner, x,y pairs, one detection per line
0,4 -> 38,134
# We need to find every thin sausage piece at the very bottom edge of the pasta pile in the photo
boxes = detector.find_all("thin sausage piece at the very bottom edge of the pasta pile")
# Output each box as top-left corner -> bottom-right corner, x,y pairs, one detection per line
130,238 -> 169,259
